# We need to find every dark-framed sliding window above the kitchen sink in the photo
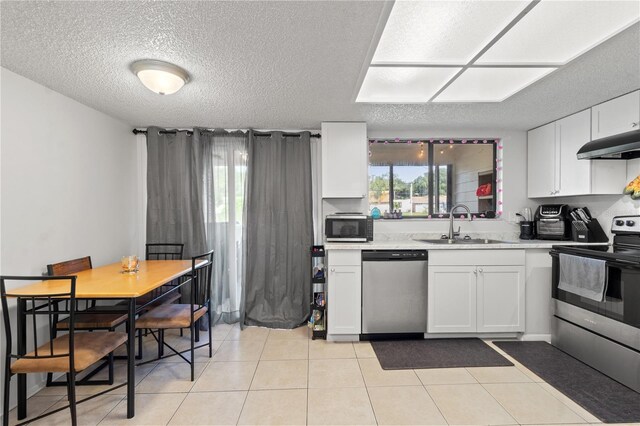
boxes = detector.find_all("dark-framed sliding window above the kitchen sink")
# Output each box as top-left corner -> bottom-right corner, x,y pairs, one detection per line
369,139 -> 502,219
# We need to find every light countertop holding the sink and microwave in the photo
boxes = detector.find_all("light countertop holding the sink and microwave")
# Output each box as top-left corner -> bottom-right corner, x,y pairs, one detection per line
324,239 -> 609,250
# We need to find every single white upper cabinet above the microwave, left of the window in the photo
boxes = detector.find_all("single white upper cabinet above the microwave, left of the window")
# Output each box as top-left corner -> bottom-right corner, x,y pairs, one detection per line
322,123 -> 368,198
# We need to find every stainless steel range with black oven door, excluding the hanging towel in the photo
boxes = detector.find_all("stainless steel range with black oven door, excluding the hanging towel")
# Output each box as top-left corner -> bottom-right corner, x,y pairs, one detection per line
550,215 -> 640,392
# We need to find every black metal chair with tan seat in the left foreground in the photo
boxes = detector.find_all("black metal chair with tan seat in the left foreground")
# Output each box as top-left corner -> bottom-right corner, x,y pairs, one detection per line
0,276 -> 127,426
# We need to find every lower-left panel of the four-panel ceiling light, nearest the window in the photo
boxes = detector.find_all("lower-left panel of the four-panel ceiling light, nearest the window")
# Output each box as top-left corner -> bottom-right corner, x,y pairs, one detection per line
356,67 -> 460,103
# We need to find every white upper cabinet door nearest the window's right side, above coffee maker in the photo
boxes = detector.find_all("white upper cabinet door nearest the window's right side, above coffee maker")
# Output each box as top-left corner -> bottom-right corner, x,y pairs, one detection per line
527,122 -> 557,198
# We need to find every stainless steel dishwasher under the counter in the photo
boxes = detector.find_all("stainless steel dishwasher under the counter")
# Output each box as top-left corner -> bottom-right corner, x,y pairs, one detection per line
362,250 -> 428,334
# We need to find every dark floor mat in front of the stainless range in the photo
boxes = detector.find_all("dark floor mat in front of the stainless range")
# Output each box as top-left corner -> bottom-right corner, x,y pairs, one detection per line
493,342 -> 640,423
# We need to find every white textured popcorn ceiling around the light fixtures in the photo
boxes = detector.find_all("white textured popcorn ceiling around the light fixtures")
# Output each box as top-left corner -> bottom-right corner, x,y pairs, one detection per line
0,1 -> 640,130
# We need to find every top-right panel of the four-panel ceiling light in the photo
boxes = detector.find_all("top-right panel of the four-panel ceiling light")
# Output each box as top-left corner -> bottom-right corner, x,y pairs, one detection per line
476,0 -> 640,65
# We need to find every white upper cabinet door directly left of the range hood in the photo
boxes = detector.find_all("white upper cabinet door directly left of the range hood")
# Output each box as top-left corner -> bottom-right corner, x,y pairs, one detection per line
556,109 -> 591,196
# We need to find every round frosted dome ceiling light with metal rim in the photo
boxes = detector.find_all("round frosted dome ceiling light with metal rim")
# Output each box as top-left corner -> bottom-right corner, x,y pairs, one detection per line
131,59 -> 190,95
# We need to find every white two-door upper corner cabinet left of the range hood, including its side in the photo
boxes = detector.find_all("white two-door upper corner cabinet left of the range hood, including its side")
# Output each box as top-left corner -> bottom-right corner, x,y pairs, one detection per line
527,109 -> 626,198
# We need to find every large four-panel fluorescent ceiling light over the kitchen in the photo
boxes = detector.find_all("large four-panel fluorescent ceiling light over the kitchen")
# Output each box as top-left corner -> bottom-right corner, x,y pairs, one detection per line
355,0 -> 640,104
